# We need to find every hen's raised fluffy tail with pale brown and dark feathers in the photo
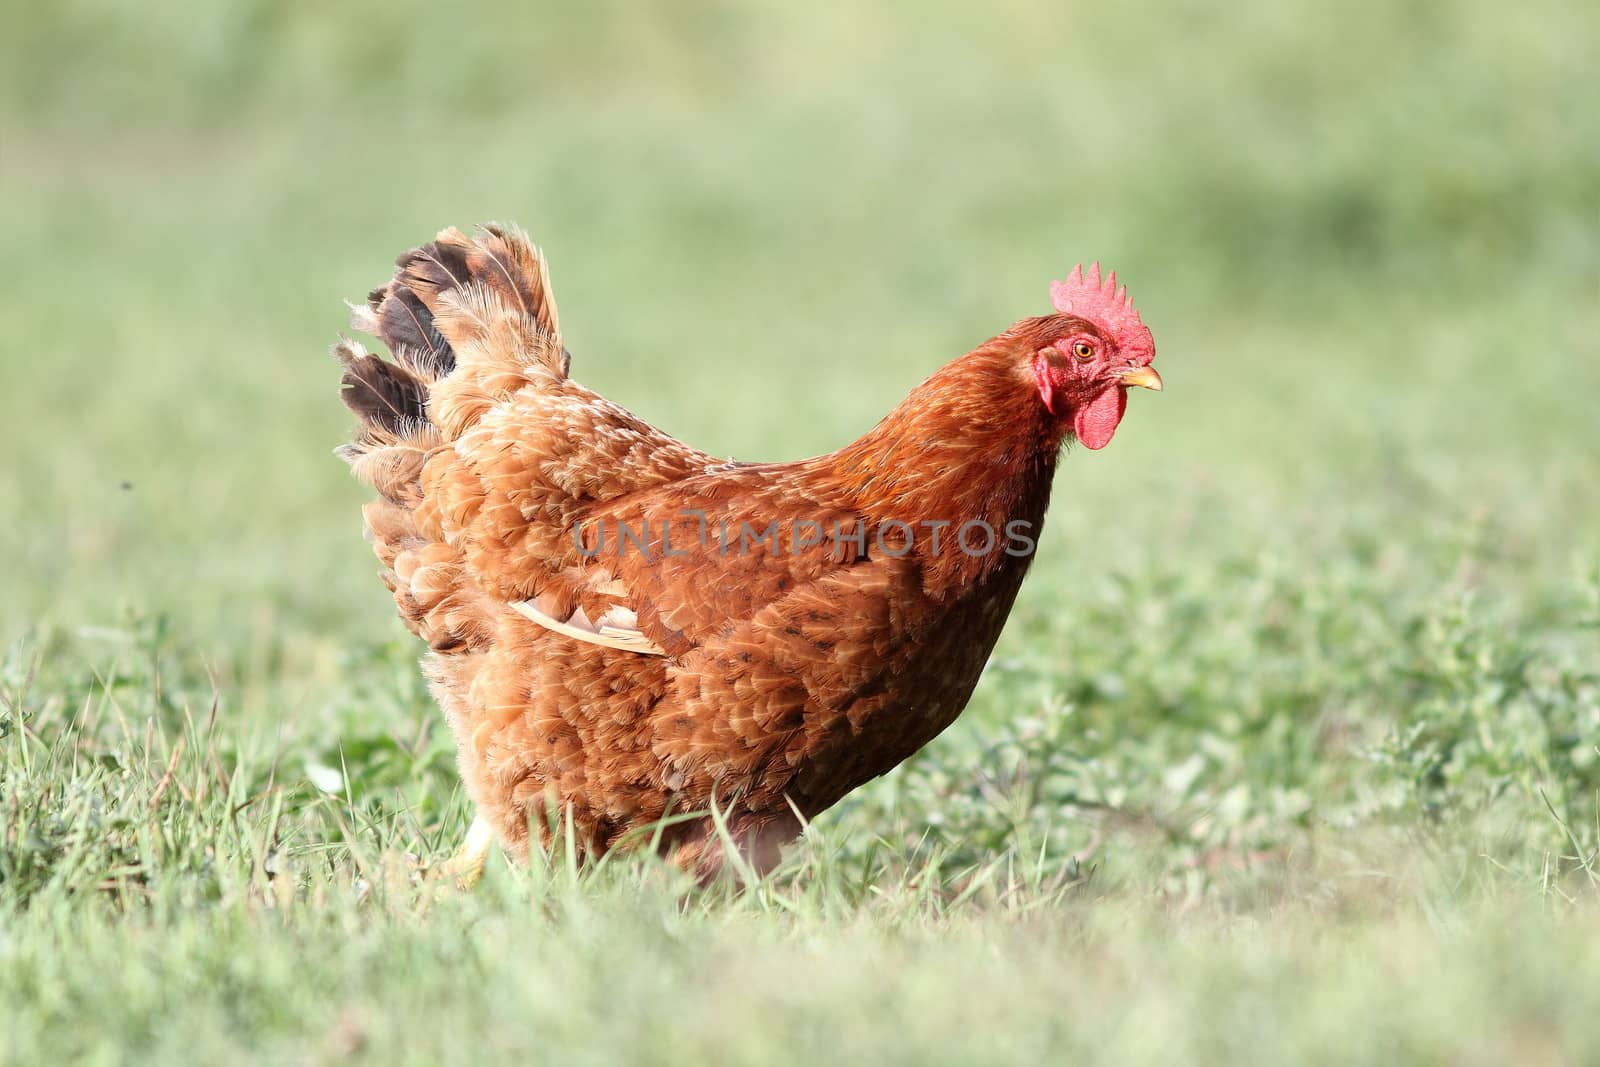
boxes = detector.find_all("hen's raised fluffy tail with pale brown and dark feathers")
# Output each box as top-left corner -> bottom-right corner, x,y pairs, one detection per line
333,226 -> 570,653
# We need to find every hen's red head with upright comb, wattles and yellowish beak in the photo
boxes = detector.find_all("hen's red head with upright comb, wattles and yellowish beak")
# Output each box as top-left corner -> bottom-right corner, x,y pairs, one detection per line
1034,264 -> 1162,448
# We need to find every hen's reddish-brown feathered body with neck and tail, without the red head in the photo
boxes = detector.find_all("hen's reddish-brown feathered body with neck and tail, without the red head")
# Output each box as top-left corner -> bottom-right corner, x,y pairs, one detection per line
338,229 -> 1152,875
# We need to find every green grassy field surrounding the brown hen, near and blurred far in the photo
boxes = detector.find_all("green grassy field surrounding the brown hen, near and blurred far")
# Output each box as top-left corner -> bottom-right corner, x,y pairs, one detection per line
0,0 -> 1600,1064
